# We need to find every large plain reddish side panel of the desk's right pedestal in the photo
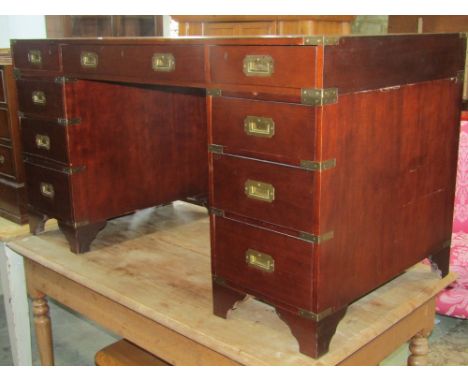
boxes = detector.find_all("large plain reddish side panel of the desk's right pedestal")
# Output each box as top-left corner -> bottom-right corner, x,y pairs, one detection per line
316,79 -> 461,311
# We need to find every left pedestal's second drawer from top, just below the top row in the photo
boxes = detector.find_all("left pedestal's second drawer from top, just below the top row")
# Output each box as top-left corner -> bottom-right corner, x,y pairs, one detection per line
16,80 -> 65,118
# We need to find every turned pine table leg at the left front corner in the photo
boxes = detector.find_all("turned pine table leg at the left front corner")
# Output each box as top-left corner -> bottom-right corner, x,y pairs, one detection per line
30,291 -> 54,366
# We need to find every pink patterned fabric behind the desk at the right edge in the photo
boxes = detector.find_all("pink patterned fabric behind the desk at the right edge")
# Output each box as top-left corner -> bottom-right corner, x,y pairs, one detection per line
436,121 -> 468,319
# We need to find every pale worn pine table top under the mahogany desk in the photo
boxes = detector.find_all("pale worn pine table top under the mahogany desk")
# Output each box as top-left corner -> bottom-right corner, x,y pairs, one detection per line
8,202 -> 455,365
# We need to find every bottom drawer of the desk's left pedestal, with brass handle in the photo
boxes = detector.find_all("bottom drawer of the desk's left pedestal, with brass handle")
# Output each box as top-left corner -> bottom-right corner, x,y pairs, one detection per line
24,161 -> 73,221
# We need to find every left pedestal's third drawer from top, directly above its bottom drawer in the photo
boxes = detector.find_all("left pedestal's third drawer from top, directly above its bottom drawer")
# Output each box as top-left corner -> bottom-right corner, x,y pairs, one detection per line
21,118 -> 69,164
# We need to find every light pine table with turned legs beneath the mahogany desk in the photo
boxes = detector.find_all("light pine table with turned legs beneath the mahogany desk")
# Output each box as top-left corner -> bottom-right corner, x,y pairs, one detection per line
8,202 -> 455,365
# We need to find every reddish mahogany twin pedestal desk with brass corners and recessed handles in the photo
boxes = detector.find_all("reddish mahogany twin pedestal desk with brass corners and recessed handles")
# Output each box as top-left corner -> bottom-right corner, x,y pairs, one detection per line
12,34 -> 466,357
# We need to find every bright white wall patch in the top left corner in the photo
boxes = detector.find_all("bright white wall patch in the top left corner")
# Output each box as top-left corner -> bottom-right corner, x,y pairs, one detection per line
0,16 -> 46,48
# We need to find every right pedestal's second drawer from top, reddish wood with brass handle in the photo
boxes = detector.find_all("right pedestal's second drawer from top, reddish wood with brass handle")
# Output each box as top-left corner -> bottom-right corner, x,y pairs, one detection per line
212,97 -> 315,165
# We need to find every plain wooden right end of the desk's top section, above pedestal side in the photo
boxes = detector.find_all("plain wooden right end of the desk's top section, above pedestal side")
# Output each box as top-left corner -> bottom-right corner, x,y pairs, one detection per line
323,34 -> 466,94
